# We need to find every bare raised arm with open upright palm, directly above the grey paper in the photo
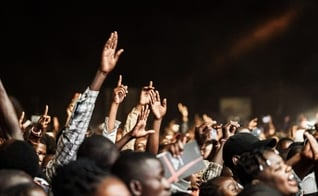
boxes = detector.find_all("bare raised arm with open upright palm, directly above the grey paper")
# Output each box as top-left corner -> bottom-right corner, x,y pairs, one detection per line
146,90 -> 167,154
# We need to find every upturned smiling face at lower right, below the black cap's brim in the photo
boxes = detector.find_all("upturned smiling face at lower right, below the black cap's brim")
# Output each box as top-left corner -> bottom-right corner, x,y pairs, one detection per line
259,151 -> 298,195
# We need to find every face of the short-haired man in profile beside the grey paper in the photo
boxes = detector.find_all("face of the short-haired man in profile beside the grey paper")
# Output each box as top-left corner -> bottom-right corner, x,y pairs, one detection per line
140,159 -> 171,196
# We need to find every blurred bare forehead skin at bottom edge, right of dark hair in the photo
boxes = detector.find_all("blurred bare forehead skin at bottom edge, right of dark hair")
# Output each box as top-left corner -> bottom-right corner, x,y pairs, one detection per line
94,177 -> 130,196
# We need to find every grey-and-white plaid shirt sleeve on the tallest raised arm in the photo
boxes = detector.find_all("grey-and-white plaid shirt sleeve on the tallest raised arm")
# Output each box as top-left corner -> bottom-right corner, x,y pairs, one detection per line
45,88 -> 99,180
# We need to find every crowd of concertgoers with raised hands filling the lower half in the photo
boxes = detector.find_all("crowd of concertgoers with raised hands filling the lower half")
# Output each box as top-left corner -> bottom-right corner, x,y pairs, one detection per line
0,32 -> 318,196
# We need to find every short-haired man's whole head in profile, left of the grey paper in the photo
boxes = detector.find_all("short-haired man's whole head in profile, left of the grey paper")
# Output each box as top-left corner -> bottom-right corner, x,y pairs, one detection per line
112,151 -> 171,196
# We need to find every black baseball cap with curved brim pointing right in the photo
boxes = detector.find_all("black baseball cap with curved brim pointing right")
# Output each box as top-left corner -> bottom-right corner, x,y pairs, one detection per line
223,132 -> 277,169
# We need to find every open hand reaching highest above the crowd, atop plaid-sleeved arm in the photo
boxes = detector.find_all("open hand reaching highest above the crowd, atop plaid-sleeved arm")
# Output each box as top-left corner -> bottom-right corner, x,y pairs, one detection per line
100,31 -> 124,73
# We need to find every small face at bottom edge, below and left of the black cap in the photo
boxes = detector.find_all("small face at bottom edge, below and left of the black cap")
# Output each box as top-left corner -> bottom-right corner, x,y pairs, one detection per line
219,177 -> 242,196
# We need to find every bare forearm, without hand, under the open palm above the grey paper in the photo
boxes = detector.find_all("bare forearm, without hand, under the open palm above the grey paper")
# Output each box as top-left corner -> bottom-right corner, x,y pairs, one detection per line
146,119 -> 162,155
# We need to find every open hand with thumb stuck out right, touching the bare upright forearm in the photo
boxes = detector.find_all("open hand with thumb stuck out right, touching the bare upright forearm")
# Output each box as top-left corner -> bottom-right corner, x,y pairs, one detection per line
131,105 -> 155,138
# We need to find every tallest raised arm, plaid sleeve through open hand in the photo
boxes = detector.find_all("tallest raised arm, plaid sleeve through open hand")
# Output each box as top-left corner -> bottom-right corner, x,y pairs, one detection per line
46,32 -> 123,179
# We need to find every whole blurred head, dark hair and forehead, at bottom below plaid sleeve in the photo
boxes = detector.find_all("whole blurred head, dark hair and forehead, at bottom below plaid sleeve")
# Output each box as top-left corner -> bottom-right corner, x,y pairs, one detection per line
52,159 -> 129,196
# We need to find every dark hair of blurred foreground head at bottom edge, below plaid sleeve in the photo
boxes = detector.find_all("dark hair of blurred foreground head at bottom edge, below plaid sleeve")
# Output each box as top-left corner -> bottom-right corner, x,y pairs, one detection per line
52,159 -> 110,196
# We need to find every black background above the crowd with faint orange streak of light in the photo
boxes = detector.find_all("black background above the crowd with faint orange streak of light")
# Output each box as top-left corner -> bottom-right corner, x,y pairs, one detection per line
0,0 -> 318,126
